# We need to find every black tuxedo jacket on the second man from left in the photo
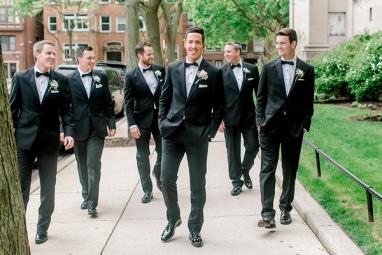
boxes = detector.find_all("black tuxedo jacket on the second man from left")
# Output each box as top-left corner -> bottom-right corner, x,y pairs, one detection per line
68,70 -> 115,140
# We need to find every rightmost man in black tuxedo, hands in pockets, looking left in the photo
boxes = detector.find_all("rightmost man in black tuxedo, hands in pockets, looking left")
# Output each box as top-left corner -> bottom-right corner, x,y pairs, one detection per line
256,28 -> 314,228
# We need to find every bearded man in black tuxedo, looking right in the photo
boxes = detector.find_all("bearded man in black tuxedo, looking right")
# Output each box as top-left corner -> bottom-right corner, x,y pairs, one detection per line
124,42 -> 165,203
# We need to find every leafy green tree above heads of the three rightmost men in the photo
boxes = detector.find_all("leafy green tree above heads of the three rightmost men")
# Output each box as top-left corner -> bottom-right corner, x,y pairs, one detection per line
185,0 -> 289,59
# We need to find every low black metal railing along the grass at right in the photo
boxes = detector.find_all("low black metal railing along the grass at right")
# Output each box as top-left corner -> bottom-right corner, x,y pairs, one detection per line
304,138 -> 382,222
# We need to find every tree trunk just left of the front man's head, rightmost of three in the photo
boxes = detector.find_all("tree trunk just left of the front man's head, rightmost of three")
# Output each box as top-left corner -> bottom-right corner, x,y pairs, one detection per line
162,0 -> 183,63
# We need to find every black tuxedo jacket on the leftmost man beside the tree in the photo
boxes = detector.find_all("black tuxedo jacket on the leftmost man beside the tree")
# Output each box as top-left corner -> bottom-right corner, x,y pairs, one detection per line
10,68 -> 73,151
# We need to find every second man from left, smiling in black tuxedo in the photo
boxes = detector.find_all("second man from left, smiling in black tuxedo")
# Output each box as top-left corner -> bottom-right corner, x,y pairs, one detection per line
69,46 -> 116,216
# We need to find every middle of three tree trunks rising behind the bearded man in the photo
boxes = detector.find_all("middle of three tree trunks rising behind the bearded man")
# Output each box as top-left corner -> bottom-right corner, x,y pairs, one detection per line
141,0 -> 163,65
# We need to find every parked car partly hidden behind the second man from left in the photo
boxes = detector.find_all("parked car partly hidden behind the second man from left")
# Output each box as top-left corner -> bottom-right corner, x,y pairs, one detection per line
56,64 -> 125,117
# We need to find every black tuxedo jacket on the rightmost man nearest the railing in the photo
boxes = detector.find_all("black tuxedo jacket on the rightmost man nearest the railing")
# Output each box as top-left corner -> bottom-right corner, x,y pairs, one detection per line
256,58 -> 314,137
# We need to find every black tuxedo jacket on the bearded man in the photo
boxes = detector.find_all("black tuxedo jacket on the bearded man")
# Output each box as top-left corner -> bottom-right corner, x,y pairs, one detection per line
124,65 -> 165,128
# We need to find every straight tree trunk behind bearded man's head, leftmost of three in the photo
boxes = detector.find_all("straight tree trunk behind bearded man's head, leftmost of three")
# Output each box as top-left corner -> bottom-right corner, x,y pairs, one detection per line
125,0 -> 139,70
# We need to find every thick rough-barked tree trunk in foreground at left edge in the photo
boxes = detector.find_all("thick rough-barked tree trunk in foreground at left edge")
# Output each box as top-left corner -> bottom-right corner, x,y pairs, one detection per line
0,45 -> 30,255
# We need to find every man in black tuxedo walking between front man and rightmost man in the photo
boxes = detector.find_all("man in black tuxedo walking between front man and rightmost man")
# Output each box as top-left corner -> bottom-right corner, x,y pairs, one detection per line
219,42 -> 260,196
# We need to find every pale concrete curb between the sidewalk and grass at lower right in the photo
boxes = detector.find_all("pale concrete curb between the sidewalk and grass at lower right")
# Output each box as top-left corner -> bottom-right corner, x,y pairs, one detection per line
276,164 -> 364,255
